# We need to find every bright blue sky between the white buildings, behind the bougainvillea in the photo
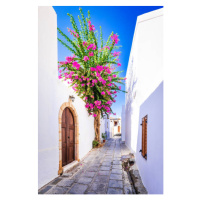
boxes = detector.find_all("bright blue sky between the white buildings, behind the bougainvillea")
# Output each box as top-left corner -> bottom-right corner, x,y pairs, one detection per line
53,6 -> 162,116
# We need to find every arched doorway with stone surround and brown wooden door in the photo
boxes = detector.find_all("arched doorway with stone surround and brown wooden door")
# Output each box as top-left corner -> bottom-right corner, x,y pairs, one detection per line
58,99 -> 79,175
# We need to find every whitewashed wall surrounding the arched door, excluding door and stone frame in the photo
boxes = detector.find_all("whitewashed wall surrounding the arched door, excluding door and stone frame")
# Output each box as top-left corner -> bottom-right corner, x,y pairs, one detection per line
38,6 -> 94,188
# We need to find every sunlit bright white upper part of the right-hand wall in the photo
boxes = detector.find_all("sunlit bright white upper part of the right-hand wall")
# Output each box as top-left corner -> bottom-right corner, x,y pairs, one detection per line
125,9 -> 163,152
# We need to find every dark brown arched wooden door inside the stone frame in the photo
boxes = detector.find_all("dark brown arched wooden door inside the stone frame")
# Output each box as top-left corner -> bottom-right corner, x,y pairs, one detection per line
62,108 -> 75,166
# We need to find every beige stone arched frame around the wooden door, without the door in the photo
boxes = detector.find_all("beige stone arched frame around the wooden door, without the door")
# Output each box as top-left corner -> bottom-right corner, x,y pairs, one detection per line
58,99 -> 80,175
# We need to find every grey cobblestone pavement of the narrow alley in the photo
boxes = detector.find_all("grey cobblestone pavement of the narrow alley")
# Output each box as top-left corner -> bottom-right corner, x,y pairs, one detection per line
39,136 -> 135,194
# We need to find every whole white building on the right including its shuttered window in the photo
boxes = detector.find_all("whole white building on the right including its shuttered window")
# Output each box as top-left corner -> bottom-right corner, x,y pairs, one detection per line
125,9 -> 163,194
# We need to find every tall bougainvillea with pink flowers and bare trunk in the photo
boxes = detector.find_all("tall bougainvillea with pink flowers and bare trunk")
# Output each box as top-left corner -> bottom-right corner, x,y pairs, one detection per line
58,8 -> 125,143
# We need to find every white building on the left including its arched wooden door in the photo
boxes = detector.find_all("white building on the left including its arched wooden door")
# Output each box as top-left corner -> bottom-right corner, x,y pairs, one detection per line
38,6 -> 95,188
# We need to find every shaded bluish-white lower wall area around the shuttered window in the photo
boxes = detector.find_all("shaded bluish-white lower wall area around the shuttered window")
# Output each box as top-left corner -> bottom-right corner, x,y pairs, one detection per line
136,82 -> 163,194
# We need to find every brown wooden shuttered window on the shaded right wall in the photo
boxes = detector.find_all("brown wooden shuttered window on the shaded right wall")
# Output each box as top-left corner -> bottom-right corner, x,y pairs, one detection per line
140,115 -> 147,159
